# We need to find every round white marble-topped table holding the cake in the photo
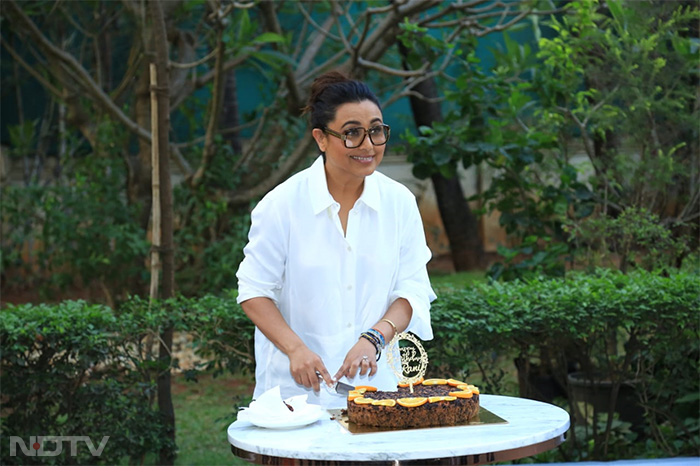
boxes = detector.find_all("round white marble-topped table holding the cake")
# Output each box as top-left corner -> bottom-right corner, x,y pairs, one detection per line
228,394 -> 569,465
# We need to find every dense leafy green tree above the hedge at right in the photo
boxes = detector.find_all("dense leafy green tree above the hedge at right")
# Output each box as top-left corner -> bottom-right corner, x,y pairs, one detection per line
402,1 -> 700,278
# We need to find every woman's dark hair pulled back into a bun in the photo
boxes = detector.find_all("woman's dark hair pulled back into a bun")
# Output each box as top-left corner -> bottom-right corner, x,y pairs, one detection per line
303,71 -> 382,129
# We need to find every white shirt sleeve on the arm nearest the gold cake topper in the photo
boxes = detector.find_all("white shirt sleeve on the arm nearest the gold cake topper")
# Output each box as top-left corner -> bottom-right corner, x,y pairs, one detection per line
390,198 -> 437,340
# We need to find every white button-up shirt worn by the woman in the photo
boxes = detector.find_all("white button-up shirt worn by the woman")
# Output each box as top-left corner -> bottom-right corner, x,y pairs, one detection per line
237,157 -> 436,408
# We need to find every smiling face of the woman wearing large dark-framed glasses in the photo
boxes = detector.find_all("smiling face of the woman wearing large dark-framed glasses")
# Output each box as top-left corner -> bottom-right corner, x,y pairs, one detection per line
313,100 -> 386,181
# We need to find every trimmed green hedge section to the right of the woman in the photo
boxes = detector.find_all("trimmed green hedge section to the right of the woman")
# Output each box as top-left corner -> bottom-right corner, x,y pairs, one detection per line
426,269 -> 700,459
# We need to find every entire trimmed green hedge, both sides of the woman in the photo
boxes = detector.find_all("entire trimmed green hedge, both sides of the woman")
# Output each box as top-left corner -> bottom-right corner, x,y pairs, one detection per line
0,271 -> 700,464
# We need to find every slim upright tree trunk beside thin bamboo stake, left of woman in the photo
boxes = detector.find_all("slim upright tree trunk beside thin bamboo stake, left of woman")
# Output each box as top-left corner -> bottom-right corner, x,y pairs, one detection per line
149,0 -> 175,465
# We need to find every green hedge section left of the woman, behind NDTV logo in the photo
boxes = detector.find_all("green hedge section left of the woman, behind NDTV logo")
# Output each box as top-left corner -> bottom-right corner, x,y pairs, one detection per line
0,292 -> 254,464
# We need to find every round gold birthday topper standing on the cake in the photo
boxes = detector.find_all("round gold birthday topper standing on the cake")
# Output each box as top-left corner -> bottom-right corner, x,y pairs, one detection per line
387,332 -> 428,392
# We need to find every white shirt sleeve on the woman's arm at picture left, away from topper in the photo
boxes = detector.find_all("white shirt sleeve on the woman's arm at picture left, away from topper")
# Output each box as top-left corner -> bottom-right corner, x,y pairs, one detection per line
236,195 -> 287,304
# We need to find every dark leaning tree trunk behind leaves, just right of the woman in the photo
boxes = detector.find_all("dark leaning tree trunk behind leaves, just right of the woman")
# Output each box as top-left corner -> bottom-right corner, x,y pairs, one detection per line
399,44 -> 484,271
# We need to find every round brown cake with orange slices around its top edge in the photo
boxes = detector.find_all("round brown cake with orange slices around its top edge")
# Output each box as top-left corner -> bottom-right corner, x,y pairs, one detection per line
347,379 -> 479,428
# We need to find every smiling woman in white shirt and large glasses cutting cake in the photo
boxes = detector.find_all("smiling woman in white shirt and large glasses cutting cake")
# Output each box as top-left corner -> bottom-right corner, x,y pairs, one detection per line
237,72 -> 436,408
